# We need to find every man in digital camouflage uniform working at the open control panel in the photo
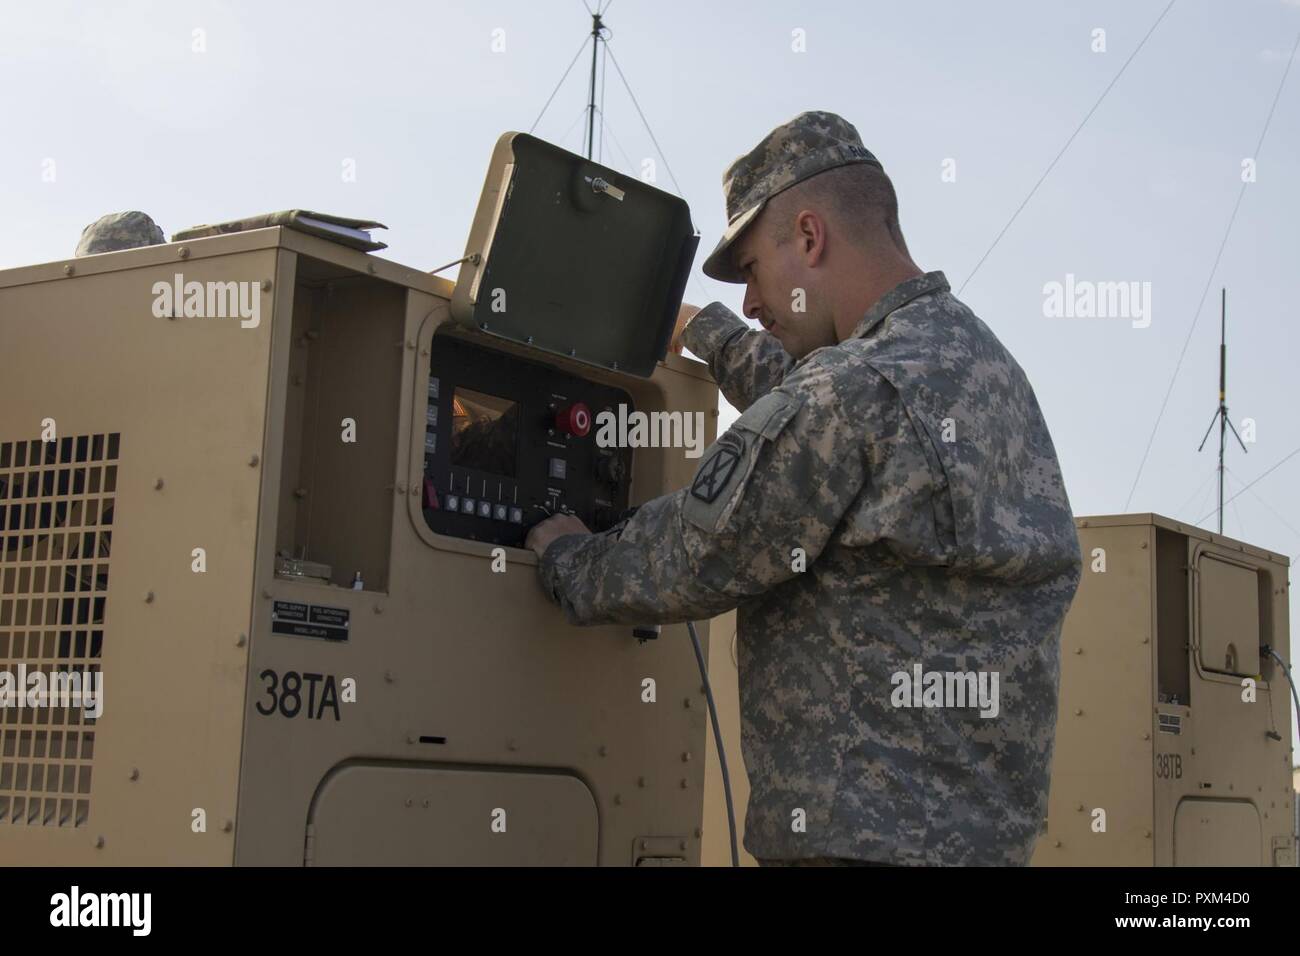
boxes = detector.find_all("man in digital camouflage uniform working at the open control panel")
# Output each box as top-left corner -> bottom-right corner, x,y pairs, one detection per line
528,112 -> 1082,865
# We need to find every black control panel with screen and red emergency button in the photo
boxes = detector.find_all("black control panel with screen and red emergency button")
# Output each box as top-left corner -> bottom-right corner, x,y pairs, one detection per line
423,336 -> 632,548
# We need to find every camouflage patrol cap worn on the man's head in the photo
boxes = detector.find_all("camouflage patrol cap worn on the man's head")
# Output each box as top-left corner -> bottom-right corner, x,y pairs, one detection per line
703,111 -> 880,282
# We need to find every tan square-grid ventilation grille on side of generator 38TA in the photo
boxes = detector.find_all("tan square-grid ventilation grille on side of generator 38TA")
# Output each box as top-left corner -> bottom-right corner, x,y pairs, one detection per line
0,434 -> 118,827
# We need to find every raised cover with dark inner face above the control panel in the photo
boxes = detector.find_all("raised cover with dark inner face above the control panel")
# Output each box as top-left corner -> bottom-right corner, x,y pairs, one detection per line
451,133 -> 699,377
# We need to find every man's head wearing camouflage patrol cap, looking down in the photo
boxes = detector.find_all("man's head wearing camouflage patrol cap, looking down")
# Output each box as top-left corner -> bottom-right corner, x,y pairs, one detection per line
705,112 -> 915,358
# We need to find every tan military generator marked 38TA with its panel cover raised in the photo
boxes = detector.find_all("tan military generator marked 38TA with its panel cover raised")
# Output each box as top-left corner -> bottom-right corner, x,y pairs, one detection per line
0,137 -> 733,865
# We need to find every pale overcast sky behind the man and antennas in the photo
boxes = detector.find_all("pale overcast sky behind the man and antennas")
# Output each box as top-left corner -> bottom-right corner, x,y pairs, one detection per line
0,0 -> 1300,754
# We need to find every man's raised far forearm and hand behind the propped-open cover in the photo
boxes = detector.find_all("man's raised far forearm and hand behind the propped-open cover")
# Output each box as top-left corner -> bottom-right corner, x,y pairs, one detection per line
681,302 -> 794,411
